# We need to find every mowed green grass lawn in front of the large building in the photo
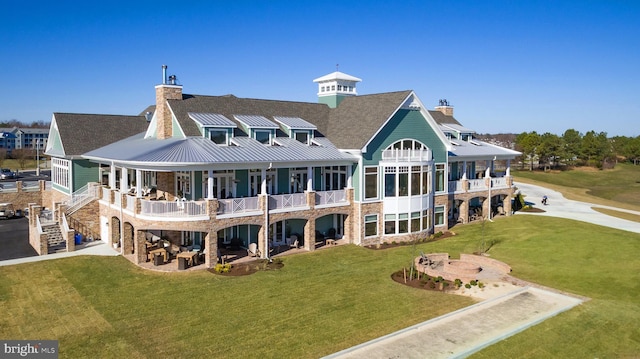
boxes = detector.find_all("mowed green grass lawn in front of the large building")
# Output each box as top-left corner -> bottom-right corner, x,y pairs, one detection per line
0,215 -> 640,358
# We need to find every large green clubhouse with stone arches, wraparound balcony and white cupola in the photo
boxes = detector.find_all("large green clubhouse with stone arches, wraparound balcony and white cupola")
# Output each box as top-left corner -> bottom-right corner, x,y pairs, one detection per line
32,66 -> 519,267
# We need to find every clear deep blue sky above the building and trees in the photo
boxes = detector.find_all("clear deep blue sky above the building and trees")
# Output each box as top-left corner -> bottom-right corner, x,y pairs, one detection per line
0,0 -> 640,136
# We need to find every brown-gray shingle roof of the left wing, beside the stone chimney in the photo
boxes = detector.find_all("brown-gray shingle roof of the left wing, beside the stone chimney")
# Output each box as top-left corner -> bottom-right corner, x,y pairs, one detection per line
53,112 -> 149,156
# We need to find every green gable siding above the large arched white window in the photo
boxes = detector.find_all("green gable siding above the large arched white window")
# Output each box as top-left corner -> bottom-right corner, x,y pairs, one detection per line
363,110 -> 447,165
